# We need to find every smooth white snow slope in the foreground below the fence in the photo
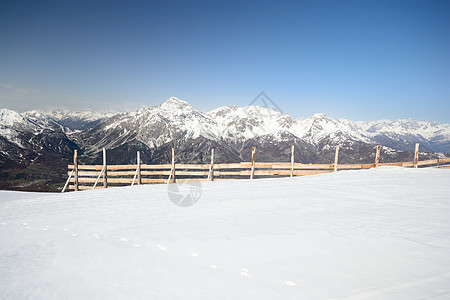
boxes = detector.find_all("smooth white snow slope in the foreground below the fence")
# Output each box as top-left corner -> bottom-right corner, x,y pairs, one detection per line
0,167 -> 450,299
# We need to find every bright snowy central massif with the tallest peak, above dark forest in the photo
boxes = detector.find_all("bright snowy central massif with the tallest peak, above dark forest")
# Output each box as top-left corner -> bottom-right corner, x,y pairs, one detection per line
82,97 -> 378,154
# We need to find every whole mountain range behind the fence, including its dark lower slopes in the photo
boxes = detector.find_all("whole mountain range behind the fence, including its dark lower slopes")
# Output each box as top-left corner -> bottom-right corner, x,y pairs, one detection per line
0,97 -> 450,190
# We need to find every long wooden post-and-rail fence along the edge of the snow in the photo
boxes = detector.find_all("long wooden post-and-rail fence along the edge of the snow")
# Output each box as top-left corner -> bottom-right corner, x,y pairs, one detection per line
62,144 -> 450,192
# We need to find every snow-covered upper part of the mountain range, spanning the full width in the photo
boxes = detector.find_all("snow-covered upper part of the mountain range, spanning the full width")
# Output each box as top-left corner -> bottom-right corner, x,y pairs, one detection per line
0,97 -> 450,151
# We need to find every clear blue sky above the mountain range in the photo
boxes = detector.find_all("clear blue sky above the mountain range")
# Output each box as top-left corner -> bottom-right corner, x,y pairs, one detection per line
0,0 -> 450,123
